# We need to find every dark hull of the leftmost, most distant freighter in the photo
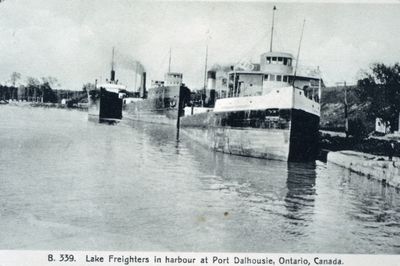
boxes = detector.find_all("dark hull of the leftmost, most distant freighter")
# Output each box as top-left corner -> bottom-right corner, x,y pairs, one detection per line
88,88 -> 122,124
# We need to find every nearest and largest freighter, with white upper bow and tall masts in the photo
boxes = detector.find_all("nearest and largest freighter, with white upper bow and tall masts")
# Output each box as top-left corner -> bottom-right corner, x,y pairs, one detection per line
180,7 -> 323,161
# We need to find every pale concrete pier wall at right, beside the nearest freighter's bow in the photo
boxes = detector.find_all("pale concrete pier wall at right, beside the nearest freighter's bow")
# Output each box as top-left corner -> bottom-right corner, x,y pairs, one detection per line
327,151 -> 400,188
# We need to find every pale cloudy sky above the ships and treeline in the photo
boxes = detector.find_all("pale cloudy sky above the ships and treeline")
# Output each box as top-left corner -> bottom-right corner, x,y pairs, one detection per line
0,0 -> 400,90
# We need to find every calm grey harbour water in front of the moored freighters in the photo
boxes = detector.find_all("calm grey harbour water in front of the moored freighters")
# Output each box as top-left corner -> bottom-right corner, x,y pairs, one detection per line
0,106 -> 400,254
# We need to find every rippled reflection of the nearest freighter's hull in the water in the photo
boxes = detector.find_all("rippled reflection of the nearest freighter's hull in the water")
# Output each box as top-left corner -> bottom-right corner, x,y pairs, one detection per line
180,134 -> 316,225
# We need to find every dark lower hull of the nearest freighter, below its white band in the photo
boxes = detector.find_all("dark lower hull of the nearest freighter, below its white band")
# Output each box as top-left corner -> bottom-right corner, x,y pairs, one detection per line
180,108 -> 319,161
